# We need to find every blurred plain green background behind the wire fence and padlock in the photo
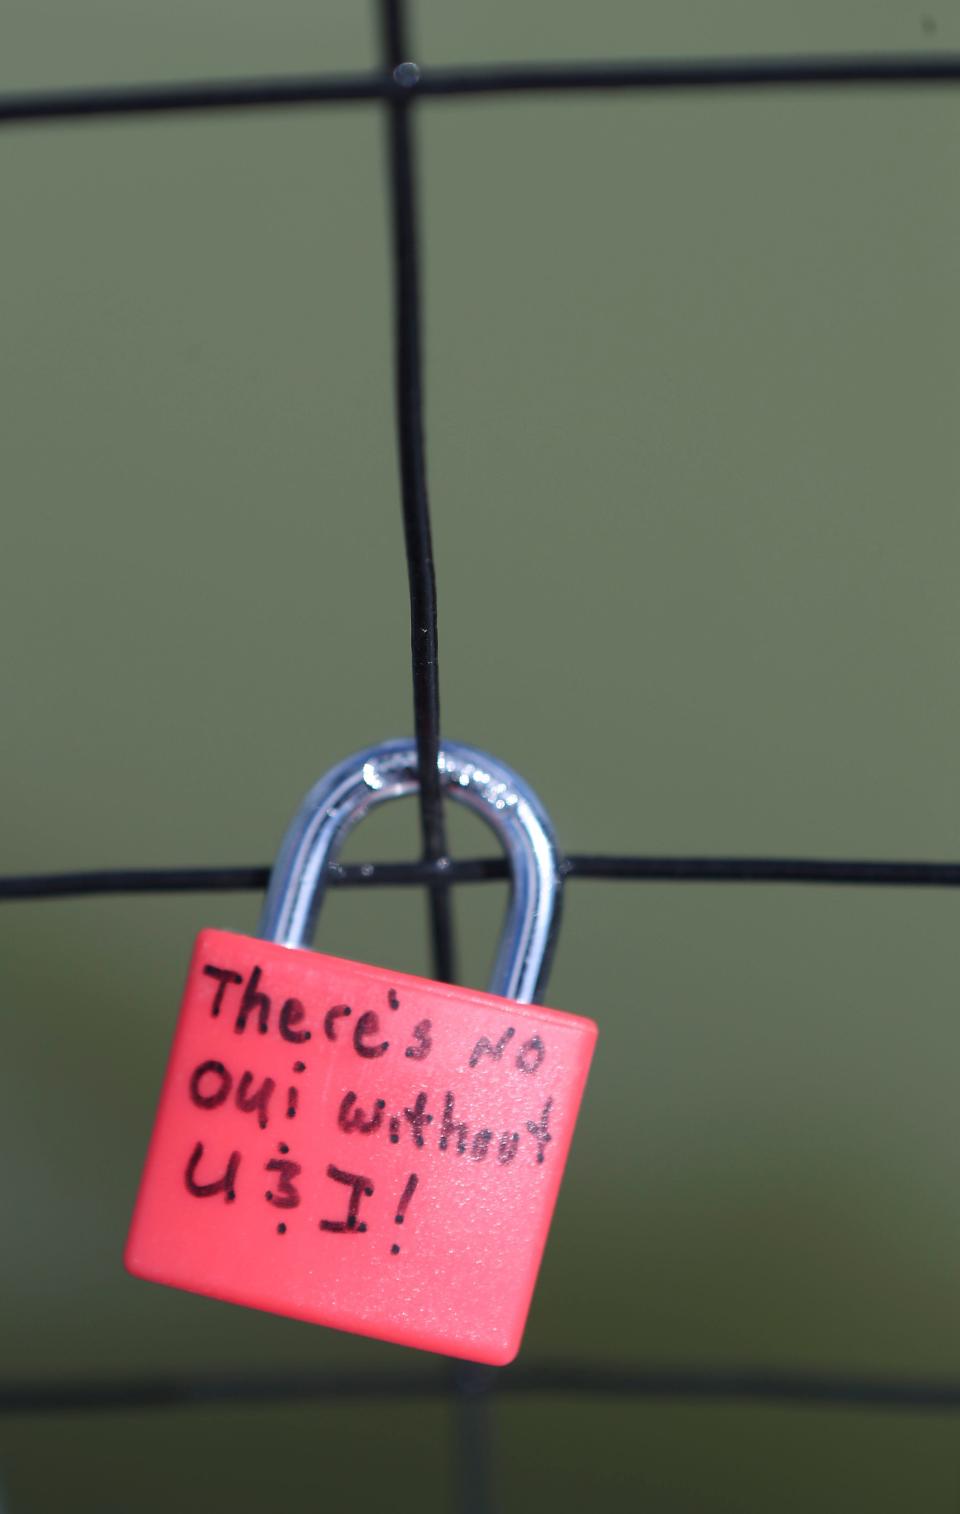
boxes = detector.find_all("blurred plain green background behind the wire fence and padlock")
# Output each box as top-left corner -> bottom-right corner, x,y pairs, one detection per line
0,0 -> 960,1514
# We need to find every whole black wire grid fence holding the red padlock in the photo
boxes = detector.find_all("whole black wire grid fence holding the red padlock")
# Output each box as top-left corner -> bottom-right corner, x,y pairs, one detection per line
0,0 -> 960,1514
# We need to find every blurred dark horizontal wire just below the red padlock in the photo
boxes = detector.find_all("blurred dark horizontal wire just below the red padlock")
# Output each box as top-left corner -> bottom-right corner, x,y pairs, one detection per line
0,1361 -> 960,1414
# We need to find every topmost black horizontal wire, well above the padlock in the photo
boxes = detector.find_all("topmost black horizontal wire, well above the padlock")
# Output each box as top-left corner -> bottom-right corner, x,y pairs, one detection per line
0,53 -> 960,124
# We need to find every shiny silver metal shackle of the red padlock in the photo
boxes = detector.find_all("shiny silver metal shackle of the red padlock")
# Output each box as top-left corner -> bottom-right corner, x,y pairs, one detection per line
257,740 -> 562,1004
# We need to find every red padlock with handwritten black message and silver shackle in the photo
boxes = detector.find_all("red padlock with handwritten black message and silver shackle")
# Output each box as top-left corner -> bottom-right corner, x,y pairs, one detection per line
124,740 -> 597,1366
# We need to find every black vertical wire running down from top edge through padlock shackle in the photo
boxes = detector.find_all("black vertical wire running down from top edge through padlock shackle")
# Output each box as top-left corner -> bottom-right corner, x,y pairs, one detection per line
380,0 -> 456,983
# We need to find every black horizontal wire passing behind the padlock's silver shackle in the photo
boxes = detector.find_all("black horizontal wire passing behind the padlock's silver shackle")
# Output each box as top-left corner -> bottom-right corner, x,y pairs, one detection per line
0,854 -> 960,901
